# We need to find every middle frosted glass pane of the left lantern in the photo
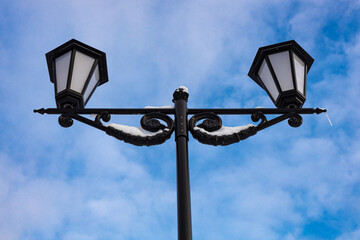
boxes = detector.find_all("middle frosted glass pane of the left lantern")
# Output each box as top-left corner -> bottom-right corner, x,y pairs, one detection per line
70,51 -> 95,93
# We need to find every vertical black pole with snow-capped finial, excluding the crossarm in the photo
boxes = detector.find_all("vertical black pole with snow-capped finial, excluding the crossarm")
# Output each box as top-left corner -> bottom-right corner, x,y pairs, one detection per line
173,88 -> 192,240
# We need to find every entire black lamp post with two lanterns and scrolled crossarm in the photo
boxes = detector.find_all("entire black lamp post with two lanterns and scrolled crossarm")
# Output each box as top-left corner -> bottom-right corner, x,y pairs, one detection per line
34,40 -> 326,240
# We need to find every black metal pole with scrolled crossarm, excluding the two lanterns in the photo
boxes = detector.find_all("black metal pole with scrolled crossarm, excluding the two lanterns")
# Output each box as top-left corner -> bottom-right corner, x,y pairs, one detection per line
34,88 -> 326,240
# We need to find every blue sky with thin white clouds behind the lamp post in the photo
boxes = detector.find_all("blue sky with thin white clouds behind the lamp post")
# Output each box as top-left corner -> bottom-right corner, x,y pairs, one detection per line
0,0 -> 360,240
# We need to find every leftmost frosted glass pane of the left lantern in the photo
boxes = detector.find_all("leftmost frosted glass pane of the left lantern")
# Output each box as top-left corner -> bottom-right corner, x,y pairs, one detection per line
55,51 -> 71,93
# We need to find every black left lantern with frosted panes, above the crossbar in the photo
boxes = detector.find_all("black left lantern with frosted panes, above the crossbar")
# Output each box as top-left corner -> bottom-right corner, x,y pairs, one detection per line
46,39 -> 108,109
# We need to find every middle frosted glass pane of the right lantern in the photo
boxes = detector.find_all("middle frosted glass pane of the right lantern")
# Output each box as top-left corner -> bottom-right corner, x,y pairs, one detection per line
269,51 -> 294,91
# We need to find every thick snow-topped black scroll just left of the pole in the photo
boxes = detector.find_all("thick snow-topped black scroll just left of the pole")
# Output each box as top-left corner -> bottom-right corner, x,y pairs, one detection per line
105,112 -> 174,146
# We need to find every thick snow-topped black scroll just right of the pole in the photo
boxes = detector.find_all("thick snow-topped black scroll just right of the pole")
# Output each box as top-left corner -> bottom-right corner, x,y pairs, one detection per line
189,113 -> 257,146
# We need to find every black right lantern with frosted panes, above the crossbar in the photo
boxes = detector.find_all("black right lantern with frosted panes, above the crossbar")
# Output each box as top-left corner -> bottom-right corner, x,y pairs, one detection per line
248,40 -> 314,108
